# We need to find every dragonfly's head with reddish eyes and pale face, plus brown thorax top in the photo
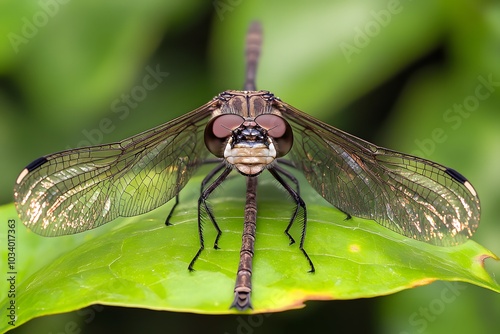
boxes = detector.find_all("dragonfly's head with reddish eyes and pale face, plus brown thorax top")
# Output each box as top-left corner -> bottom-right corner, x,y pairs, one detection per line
205,91 -> 293,176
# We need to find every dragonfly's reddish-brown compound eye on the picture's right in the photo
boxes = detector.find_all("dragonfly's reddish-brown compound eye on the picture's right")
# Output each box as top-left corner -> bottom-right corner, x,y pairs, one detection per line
255,114 -> 293,157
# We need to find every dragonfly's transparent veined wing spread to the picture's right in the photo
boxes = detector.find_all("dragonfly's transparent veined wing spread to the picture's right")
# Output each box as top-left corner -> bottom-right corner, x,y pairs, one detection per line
281,104 -> 480,246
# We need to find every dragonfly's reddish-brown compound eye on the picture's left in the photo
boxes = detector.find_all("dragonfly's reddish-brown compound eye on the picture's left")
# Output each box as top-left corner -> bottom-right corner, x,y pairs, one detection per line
205,114 -> 245,158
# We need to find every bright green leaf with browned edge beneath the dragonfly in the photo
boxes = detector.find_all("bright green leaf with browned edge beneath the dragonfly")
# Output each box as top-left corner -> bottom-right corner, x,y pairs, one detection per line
0,173 -> 500,331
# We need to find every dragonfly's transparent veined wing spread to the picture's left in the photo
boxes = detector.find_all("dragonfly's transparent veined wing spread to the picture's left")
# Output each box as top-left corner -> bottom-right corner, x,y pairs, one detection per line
14,102 -> 214,236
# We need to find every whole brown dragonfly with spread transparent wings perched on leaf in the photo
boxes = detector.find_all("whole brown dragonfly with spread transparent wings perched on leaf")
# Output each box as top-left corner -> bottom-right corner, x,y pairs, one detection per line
14,22 -> 480,311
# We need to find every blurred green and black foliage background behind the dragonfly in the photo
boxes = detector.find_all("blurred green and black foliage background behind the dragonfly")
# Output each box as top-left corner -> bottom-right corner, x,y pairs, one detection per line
0,0 -> 500,333
